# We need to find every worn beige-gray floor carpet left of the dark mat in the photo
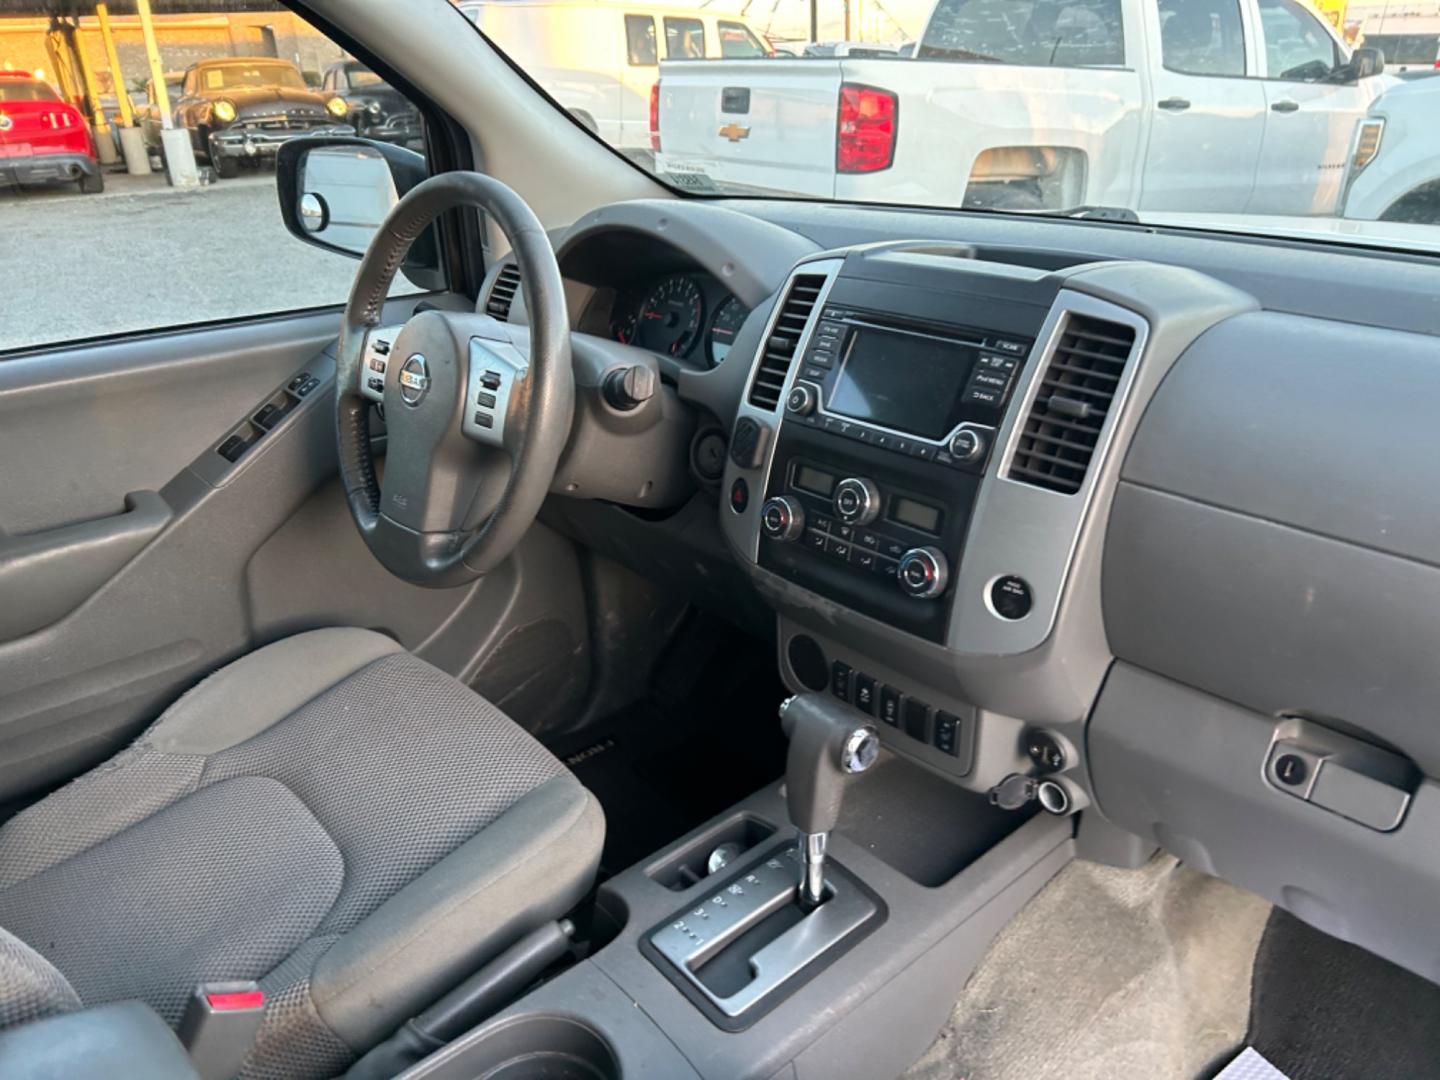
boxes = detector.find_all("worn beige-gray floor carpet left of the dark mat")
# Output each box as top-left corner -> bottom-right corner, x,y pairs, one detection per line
904,855 -> 1270,1080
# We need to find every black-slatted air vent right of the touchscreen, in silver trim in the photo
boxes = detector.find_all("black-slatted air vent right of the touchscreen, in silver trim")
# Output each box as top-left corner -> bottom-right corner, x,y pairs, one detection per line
1008,314 -> 1135,495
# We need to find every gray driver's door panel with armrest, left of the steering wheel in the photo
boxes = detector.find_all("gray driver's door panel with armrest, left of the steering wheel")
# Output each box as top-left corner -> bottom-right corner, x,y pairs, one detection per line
0,300 -> 588,804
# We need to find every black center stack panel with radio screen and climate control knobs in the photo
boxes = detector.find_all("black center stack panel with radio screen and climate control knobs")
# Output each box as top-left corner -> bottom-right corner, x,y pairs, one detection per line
759,304 -> 1032,641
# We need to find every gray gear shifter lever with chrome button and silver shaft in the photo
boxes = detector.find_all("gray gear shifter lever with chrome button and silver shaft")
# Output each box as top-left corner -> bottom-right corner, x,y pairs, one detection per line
780,694 -> 880,909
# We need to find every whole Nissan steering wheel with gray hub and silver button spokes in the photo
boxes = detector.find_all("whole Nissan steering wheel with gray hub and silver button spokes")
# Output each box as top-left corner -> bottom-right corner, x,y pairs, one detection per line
336,171 -> 575,588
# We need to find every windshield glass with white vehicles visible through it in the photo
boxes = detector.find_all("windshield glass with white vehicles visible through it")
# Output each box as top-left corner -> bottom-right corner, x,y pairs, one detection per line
462,0 -> 1440,253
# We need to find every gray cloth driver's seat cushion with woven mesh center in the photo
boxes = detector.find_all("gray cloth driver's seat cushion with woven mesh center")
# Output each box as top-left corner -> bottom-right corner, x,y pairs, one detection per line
0,629 -> 605,1077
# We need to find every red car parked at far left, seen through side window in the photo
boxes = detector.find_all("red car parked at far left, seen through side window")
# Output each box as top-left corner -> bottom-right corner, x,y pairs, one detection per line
0,71 -> 105,194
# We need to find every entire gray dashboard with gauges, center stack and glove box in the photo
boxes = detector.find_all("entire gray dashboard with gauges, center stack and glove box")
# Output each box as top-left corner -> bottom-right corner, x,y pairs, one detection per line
480,200 -> 1440,996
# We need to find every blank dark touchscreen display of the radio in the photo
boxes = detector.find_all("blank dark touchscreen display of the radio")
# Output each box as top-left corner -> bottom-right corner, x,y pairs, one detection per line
829,327 -> 978,439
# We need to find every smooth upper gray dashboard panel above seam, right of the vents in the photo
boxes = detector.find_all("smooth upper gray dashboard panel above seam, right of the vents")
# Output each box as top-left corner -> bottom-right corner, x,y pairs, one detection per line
1123,311 -> 1440,564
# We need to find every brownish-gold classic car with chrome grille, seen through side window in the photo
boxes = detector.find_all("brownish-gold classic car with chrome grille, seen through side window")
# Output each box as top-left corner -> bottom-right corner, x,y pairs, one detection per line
171,56 -> 354,180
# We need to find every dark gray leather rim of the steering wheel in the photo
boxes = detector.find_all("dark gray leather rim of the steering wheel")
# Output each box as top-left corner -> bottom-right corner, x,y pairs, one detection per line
336,171 -> 575,588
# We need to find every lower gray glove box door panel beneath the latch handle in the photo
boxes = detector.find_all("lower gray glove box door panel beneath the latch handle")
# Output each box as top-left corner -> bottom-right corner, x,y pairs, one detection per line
1089,664 -> 1440,981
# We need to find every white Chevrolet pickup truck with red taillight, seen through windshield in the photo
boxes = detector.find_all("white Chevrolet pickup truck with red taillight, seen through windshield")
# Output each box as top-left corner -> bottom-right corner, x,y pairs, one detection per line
657,0 -> 1394,216
